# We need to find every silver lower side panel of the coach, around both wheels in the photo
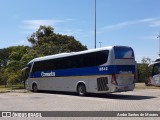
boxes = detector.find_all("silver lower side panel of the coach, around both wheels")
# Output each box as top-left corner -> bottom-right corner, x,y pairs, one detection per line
26,76 -> 89,92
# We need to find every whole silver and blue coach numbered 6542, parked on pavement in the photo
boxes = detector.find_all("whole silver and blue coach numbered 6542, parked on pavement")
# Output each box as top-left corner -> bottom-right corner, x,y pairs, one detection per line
23,46 -> 136,96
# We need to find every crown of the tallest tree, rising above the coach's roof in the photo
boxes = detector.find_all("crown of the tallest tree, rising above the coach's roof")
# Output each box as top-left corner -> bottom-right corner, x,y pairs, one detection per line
28,26 -> 87,56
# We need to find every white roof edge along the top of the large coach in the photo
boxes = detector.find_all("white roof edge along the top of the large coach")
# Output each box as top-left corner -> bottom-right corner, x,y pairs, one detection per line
29,46 -> 132,63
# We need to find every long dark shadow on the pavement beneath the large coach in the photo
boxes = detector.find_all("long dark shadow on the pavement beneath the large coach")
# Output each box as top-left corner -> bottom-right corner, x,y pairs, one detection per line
37,91 -> 156,100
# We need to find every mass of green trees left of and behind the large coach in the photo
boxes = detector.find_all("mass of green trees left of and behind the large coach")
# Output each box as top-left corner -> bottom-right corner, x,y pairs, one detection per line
0,26 -> 87,85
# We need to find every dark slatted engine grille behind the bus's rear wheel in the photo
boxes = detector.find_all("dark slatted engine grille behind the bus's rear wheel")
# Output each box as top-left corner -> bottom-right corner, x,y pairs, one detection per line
97,77 -> 109,91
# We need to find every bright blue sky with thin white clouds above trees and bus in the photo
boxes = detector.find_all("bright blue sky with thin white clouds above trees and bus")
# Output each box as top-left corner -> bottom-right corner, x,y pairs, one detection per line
0,0 -> 160,62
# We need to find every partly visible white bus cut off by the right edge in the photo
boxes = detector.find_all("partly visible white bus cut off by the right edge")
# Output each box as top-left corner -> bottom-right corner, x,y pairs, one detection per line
148,58 -> 160,86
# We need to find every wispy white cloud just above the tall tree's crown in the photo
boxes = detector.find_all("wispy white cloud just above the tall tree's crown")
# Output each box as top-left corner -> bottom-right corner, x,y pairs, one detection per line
20,18 -> 83,36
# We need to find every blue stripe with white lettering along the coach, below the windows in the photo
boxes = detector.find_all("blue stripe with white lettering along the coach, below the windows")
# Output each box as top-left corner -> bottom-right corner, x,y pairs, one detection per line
30,65 -> 135,78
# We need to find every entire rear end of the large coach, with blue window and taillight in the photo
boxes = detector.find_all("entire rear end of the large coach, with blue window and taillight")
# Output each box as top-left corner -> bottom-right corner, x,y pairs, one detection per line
110,46 -> 136,92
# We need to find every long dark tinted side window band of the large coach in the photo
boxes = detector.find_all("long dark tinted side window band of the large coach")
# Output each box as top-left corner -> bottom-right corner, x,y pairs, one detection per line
33,50 -> 109,72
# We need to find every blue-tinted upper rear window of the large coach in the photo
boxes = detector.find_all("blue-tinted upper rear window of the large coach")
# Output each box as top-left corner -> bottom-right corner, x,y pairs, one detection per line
114,47 -> 134,59
